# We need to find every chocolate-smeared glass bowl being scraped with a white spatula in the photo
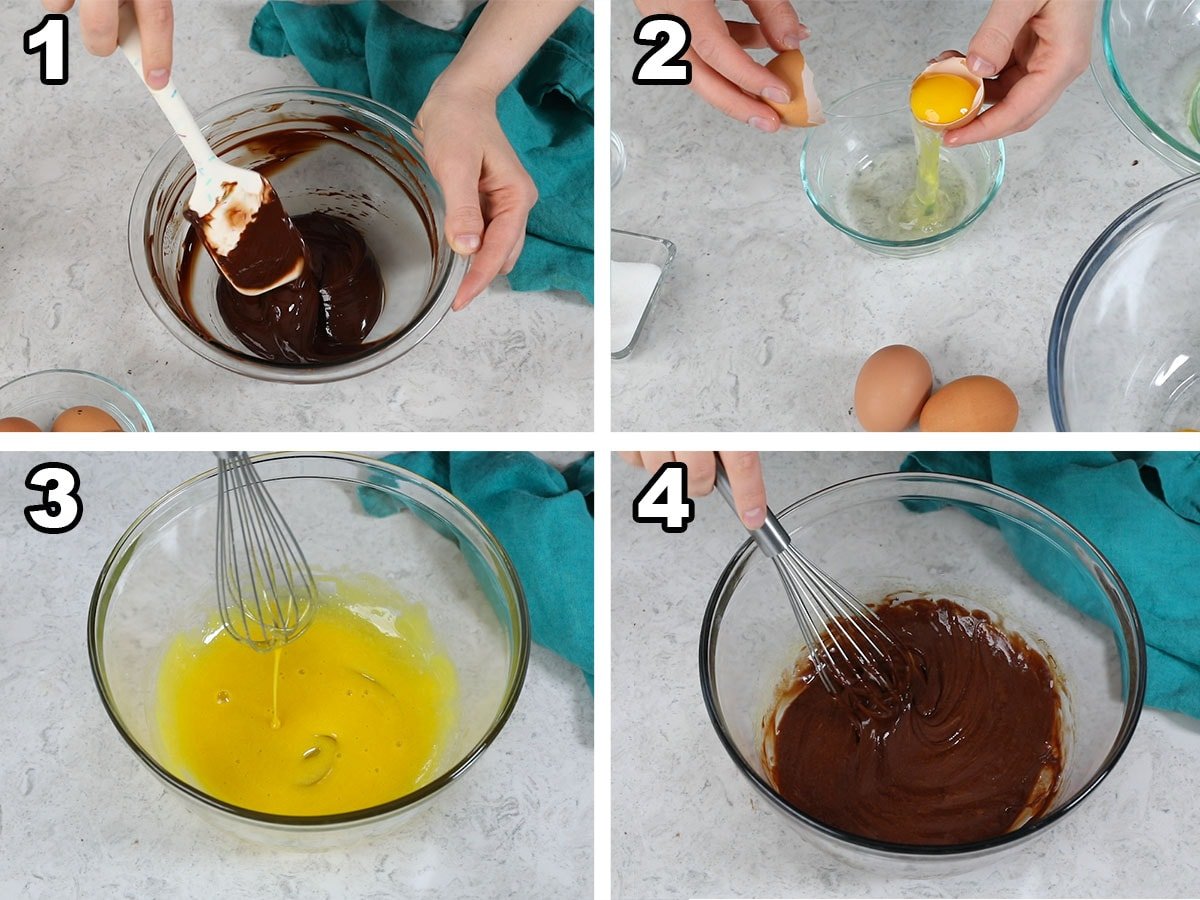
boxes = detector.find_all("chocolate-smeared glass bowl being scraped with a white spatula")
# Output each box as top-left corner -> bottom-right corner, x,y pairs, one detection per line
128,82 -> 467,383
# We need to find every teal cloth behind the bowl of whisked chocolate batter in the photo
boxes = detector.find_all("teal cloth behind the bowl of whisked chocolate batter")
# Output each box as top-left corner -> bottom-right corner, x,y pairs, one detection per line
900,452 -> 1200,718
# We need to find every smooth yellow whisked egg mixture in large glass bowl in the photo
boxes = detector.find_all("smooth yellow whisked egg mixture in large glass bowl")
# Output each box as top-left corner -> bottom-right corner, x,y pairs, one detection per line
157,584 -> 457,816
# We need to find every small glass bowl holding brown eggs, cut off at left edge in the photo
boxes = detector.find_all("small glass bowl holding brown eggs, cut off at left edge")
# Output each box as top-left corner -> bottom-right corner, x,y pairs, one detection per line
0,368 -> 154,431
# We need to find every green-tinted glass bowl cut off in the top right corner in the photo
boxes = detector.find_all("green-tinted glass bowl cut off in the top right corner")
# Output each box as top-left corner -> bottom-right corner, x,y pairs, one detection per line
1092,0 -> 1200,173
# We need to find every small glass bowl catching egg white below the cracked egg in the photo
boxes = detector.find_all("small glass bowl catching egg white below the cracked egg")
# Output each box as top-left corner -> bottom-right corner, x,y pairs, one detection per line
800,78 -> 1004,258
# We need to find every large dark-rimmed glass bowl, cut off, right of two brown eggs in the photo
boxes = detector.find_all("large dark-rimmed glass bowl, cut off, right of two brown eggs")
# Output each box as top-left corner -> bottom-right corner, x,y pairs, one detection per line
1048,175 -> 1200,431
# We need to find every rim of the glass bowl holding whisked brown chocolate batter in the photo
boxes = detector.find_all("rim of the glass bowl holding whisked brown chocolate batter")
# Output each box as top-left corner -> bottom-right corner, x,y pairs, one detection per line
700,472 -> 1146,859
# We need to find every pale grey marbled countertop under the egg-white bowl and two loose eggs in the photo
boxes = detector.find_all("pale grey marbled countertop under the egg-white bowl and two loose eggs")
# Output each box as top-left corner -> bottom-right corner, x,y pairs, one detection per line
612,0 -> 1177,431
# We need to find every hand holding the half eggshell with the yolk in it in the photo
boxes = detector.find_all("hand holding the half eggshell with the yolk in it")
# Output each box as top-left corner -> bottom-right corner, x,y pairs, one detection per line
943,0 -> 1097,146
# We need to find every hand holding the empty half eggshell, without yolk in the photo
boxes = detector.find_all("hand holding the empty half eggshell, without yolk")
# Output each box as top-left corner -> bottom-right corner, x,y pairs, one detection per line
635,0 -> 809,132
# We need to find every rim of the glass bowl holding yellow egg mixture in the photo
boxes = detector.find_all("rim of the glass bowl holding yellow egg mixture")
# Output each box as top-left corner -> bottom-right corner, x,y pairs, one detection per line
88,452 -> 530,832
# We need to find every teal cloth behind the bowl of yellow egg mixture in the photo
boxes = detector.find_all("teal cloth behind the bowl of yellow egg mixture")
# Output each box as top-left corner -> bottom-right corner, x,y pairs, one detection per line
359,451 -> 595,688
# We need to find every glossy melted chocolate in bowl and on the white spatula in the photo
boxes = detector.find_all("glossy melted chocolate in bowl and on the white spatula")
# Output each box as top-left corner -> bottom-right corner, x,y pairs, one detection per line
169,116 -> 437,365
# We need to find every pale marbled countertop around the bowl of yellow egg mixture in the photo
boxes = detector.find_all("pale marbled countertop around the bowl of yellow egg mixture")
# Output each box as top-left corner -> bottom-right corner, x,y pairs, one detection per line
0,452 -> 593,898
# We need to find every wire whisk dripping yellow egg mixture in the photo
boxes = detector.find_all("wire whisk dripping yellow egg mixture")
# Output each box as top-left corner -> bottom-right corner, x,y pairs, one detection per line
216,452 -> 317,650
